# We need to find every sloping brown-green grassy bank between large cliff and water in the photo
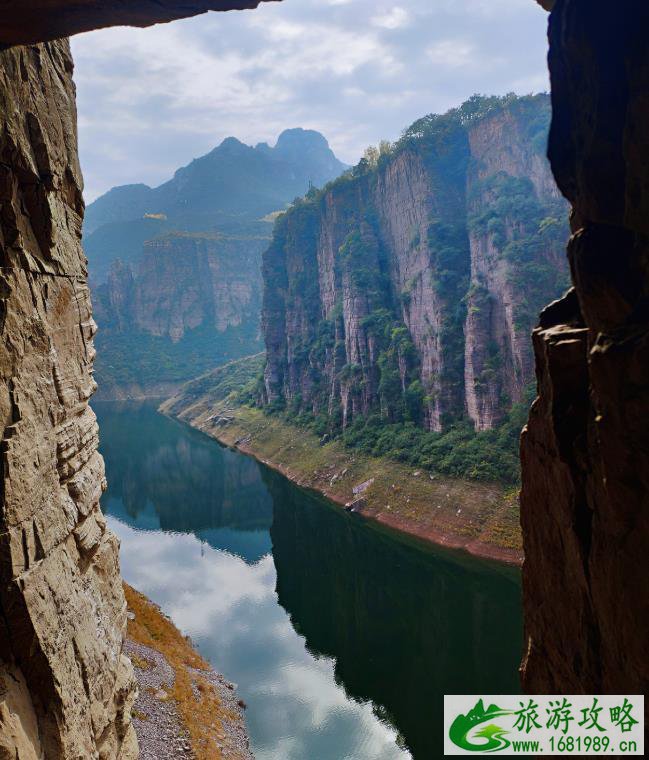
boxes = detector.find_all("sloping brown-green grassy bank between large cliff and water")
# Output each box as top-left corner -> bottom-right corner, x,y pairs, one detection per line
160,360 -> 522,564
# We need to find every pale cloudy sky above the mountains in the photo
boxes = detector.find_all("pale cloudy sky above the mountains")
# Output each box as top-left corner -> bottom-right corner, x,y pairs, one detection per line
72,0 -> 549,202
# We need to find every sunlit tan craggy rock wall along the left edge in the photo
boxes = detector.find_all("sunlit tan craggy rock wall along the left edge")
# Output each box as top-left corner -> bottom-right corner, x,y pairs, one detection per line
0,42 -> 137,760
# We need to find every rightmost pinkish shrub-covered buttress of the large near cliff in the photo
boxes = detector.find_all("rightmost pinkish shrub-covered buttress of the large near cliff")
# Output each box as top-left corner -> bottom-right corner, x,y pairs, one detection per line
464,104 -> 566,430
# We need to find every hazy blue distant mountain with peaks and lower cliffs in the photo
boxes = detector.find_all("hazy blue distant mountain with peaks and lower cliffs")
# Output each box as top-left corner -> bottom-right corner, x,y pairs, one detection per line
84,128 -> 346,397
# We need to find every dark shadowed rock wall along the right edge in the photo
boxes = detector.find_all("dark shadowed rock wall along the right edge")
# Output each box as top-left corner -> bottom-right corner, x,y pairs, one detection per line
521,0 -> 649,694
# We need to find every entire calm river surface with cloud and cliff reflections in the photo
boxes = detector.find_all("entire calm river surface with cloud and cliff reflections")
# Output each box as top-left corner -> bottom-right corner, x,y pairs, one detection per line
94,403 -> 521,760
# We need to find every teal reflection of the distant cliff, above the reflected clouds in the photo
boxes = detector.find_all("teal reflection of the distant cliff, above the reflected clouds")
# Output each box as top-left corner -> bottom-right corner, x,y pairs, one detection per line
95,402 -> 273,559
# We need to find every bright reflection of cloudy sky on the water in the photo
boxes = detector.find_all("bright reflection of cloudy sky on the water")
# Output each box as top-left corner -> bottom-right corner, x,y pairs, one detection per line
108,517 -> 410,760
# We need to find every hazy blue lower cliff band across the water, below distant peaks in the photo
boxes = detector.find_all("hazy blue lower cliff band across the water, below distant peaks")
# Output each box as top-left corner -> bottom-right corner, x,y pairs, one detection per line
93,233 -> 268,398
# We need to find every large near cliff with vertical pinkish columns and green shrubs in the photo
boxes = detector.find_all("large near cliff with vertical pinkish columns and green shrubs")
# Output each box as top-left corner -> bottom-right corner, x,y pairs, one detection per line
263,96 -> 567,430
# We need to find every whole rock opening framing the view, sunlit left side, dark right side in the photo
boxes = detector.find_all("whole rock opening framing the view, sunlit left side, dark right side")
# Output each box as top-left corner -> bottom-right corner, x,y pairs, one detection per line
0,0 -> 649,758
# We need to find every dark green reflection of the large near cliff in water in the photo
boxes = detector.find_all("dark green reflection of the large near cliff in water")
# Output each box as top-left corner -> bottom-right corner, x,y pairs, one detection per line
264,471 -> 522,760
